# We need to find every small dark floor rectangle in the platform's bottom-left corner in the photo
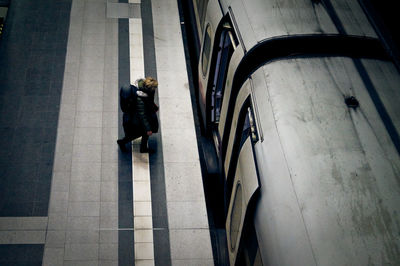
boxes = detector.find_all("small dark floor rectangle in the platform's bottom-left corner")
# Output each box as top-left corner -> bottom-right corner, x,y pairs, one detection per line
0,244 -> 44,266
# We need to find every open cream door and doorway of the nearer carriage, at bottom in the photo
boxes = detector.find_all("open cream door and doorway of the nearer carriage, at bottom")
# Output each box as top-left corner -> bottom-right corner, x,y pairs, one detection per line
226,101 -> 262,265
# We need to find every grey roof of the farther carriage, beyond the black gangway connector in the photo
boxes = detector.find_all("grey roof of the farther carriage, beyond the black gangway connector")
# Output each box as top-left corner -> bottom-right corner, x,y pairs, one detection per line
220,0 -> 377,50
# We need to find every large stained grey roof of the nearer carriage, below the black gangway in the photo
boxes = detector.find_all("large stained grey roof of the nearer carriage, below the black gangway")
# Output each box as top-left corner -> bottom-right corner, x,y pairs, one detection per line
252,57 -> 400,265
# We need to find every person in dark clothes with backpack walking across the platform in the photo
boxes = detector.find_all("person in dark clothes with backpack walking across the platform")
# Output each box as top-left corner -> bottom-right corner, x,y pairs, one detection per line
117,77 -> 158,153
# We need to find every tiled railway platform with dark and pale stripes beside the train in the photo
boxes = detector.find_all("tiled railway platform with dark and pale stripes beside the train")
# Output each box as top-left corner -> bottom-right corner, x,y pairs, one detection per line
0,0 -> 214,266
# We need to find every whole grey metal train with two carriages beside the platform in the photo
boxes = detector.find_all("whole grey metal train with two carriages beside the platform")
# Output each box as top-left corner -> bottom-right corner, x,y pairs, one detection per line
189,0 -> 400,265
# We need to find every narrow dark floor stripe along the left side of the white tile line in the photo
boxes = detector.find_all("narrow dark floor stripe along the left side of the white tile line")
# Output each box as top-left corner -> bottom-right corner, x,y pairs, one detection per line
115,0 -> 135,265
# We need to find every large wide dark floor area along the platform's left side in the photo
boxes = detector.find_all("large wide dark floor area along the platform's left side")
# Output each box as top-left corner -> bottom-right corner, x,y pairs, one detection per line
0,0 -> 71,217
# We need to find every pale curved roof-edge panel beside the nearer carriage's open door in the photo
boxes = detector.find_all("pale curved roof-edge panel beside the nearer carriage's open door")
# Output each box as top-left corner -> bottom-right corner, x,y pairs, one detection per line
248,69 -> 316,265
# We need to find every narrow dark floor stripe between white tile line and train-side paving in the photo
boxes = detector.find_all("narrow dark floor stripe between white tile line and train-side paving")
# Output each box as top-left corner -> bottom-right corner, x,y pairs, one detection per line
138,0 -> 171,265
